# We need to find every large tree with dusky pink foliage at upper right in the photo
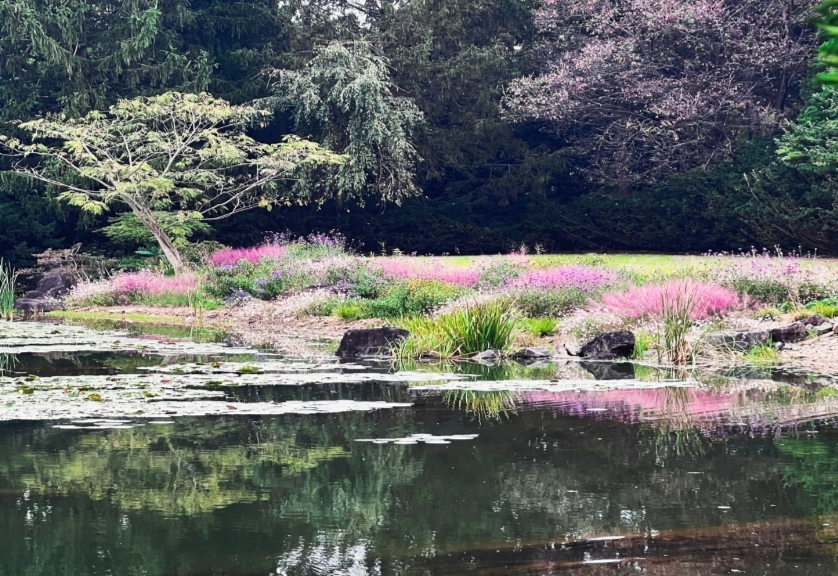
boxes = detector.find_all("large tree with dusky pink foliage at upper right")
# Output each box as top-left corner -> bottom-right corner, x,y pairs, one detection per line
504,0 -> 816,189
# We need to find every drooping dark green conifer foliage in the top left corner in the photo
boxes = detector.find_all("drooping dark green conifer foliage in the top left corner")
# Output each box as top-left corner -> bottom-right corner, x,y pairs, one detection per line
0,0 -> 212,120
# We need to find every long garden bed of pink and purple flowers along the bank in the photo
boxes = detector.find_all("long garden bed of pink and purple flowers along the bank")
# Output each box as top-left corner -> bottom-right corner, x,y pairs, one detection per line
57,235 -> 838,366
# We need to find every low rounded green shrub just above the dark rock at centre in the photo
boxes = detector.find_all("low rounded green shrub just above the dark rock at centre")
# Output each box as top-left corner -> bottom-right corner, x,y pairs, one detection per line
361,280 -> 463,318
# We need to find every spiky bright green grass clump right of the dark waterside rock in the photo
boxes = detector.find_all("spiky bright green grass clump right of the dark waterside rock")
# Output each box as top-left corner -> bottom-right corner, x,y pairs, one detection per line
393,300 -> 517,358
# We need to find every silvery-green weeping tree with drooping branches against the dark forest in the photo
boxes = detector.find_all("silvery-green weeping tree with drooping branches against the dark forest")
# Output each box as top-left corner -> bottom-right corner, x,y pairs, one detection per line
258,40 -> 423,202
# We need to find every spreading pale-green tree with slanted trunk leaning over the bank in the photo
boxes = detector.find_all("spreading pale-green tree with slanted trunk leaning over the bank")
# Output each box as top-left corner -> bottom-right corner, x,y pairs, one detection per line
0,92 -> 343,272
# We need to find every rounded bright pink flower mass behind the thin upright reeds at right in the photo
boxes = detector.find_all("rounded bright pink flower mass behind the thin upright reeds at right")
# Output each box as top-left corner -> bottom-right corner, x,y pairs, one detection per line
602,280 -> 741,320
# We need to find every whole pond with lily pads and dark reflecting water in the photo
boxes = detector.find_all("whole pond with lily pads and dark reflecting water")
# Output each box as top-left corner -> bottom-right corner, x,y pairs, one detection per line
0,323 -> 838,576
